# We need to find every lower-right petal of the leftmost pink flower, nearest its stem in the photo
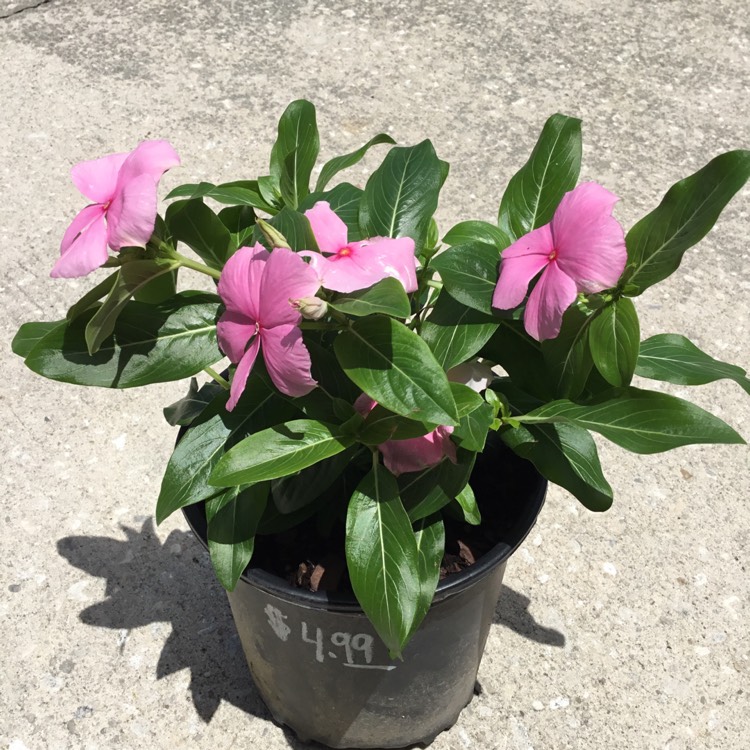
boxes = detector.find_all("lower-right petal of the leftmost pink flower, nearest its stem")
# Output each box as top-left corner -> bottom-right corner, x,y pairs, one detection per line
107,174 -> 156,250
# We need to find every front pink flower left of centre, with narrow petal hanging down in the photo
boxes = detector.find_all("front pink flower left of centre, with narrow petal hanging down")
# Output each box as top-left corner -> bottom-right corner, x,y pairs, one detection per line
217,244 -> 320,411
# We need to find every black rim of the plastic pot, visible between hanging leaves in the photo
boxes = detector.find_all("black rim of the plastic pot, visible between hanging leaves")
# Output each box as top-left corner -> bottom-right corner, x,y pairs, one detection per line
182,470 -> 547,612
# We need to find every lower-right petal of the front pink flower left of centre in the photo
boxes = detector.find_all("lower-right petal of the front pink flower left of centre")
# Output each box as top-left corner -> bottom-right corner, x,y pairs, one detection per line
261,324 -> 318,396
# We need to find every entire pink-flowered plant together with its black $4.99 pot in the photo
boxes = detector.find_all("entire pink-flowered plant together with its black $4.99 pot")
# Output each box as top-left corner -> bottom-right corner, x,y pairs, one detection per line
13,101 -> 750,747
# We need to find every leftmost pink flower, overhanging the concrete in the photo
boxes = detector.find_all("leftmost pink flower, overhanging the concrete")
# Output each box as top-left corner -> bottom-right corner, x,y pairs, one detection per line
50,141 -> 180,278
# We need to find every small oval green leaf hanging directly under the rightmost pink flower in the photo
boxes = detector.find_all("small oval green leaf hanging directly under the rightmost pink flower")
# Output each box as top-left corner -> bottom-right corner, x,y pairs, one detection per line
589,297 -> 641,387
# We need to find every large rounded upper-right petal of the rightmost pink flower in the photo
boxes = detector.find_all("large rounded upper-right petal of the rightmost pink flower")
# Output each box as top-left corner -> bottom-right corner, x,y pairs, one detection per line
551,182 -> 627,292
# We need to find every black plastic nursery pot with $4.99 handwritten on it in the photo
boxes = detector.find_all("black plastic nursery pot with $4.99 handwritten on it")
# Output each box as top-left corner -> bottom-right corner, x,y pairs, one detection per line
184,449 -> 547,748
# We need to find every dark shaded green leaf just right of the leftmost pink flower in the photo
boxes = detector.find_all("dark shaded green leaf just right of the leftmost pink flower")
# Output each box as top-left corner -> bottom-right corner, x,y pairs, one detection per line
164,198 -> 237,270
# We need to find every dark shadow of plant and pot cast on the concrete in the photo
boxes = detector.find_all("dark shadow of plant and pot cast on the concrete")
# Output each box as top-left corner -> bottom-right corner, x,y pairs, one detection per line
57,518 -> 565,750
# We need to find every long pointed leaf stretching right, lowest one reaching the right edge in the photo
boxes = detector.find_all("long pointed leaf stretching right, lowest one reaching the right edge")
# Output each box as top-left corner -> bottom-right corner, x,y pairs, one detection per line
518,387 -> 745,453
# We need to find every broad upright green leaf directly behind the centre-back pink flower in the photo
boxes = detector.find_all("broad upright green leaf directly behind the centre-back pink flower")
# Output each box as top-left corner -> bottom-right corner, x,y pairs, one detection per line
359,141 -> 443,252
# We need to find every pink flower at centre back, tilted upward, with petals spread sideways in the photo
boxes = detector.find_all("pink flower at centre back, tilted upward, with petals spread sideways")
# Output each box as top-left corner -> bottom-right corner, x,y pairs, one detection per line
300,201 -> 417,292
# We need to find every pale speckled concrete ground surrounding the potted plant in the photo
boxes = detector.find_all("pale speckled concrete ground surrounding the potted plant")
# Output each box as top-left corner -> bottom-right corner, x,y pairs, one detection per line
0,0 -> 750,750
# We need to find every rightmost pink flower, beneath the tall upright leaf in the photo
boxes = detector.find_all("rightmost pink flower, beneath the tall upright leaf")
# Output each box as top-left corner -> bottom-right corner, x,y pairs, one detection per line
492,182 -> 627,341
